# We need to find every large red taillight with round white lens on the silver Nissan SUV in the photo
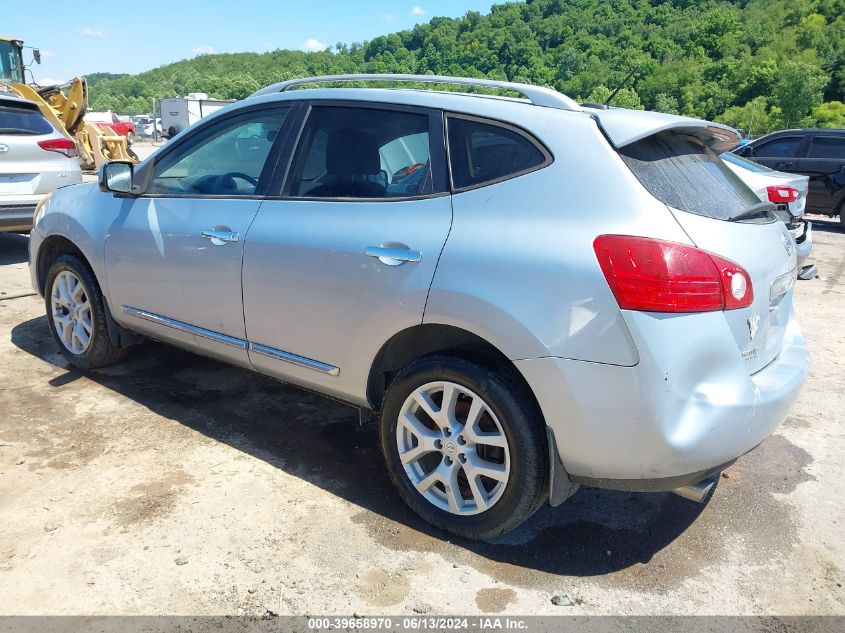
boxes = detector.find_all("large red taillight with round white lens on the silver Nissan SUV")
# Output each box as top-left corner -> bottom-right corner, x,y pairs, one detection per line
593,235 -> 754,312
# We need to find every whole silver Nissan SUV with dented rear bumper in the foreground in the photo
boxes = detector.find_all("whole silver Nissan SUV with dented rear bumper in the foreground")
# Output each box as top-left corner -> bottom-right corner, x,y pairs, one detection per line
30,75 -> 809,538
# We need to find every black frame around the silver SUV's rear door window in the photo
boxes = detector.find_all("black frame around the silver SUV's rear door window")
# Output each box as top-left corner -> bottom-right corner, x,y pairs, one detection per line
274,98 -> 451,203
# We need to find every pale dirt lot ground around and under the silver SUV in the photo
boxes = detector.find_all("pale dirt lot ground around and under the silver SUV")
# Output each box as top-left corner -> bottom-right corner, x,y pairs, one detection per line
0,214 -> 845,615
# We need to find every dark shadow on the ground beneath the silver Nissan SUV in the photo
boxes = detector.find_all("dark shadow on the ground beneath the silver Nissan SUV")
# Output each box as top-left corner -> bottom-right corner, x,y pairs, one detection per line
11,317 -> 706,576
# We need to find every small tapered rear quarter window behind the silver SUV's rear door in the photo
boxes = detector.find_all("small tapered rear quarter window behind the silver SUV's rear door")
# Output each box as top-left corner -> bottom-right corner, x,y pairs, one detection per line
447,115 -> 551,191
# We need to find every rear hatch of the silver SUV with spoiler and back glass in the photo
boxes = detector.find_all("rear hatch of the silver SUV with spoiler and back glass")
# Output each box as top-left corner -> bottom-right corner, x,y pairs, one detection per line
601,111 -> 796,373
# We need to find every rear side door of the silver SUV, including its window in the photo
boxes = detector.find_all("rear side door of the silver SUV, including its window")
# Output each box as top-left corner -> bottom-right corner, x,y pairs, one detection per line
243,102 -> 452,402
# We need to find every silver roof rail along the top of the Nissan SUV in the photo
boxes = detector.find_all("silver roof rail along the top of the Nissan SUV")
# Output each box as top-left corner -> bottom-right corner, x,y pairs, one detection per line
250,73 -> 581,112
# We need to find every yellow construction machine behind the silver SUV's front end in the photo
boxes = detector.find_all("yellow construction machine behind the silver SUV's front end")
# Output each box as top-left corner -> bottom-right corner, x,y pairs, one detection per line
0,37 -> 137,170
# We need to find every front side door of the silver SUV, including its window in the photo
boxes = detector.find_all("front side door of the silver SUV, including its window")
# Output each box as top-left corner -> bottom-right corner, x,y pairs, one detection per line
105,106 -> 289,365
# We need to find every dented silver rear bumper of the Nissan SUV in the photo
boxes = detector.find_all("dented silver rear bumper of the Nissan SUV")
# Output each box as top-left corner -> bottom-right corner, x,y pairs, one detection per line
515,313 -> 810,484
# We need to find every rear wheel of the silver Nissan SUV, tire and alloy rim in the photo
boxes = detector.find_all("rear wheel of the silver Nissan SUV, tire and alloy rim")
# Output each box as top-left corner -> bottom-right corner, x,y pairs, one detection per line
380,356 -> 548,539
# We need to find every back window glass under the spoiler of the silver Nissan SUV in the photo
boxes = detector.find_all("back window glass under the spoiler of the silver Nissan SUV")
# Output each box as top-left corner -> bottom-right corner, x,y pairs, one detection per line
619,132 -> 760,220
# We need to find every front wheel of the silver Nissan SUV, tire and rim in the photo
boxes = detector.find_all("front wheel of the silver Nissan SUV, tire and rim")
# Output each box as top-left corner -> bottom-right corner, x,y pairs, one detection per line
44,255 -> 126,370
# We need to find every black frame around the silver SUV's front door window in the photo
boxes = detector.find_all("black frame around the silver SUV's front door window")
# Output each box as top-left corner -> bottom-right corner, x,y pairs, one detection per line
129,100 -> 299,200
